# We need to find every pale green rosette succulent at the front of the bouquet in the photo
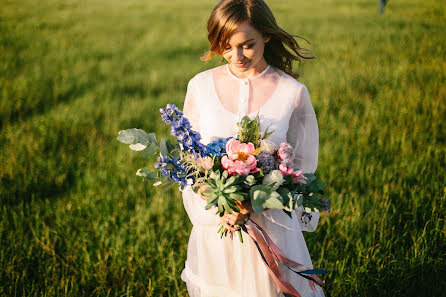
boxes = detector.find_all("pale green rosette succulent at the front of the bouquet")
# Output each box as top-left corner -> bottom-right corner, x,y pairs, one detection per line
201,170 -> 248,216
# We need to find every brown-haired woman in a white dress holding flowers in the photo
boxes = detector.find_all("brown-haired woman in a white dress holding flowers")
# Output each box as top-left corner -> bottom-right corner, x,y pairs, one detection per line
181,0 -> 324,297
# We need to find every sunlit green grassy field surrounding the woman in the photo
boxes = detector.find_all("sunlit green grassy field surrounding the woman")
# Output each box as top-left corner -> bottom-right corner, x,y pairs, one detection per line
0,0 -> 446,297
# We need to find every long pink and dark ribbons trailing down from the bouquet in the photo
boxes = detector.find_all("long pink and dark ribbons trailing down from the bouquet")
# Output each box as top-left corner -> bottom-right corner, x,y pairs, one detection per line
245,220 -> 324,297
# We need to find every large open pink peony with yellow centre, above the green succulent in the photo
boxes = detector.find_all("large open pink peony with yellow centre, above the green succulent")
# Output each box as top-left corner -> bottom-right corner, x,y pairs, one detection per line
221,138 -> 260,175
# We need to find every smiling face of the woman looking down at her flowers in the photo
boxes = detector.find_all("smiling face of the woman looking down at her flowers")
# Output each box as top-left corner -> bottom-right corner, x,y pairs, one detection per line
222,21 -> 269,77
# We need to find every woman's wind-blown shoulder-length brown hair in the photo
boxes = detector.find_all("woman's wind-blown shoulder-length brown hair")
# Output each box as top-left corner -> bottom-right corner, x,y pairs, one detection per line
201,0 -> 314,78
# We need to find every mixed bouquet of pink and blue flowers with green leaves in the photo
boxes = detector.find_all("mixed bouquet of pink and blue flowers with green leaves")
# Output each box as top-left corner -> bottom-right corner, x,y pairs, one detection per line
117,104 -> 330,242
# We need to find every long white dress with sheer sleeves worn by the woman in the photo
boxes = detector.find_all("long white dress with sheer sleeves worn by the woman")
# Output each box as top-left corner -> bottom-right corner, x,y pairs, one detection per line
181,65 -> 324,297
